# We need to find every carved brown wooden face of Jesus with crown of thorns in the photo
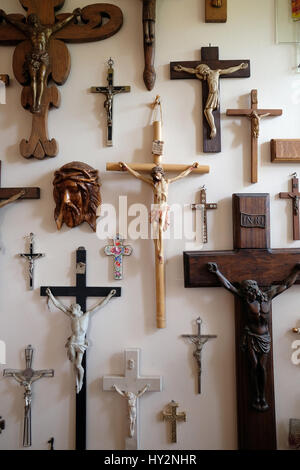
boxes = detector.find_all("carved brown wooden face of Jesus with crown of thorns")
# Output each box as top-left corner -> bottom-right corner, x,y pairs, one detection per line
53,162 -> 101,231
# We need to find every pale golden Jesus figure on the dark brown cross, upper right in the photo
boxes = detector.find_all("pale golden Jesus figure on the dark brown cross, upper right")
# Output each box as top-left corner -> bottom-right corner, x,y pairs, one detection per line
174,62 -> 248,139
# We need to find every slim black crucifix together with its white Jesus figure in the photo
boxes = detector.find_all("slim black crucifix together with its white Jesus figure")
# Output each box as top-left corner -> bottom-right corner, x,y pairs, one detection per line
41,247 -> 121,450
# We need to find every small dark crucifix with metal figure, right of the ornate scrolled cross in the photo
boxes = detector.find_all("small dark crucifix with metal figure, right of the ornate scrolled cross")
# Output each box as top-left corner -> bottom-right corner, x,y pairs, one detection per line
91,58 -> 130,147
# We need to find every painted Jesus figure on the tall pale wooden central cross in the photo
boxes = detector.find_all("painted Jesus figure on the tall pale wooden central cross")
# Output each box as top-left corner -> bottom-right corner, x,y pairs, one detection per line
120,162 -> 199,263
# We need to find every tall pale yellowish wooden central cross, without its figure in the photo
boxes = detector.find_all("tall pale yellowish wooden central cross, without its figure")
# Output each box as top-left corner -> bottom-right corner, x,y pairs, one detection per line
106,97 -> 209,328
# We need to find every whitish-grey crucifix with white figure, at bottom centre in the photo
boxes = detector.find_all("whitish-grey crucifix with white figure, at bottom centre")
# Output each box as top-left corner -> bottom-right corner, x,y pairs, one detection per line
103,349 -> 162,450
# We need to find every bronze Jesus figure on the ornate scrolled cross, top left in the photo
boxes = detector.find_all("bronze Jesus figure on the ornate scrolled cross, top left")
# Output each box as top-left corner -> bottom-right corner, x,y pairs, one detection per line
0,8 -> 81,114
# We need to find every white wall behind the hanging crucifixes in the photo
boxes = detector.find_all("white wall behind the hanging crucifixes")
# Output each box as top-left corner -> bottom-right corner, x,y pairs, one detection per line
0,0 -> 300,449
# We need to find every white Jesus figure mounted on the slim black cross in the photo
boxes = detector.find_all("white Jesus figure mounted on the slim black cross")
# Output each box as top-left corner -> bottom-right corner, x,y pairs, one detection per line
46,288 -> 116,393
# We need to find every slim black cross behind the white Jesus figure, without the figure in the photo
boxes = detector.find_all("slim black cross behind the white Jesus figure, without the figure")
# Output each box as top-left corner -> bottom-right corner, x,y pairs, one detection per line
40,246 -> 121,450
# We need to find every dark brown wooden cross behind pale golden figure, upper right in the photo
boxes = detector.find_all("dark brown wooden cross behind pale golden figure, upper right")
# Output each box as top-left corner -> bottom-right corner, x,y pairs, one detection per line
170,47 -> 250,153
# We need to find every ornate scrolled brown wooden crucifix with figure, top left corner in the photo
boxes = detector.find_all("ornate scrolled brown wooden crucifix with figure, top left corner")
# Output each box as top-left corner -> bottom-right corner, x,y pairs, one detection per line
0,0 -> 123,159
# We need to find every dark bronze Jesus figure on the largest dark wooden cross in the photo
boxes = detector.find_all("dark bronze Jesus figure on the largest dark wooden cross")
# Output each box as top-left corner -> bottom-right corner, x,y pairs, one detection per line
208,263 -> 300,411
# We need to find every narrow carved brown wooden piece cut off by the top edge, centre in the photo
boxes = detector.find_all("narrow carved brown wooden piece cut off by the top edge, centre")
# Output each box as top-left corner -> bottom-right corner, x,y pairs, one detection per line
142,0 -> 156,91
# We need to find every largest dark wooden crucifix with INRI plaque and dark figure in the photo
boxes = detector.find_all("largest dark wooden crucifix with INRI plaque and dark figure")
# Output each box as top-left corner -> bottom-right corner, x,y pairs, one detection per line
184,193 -> 300,450
